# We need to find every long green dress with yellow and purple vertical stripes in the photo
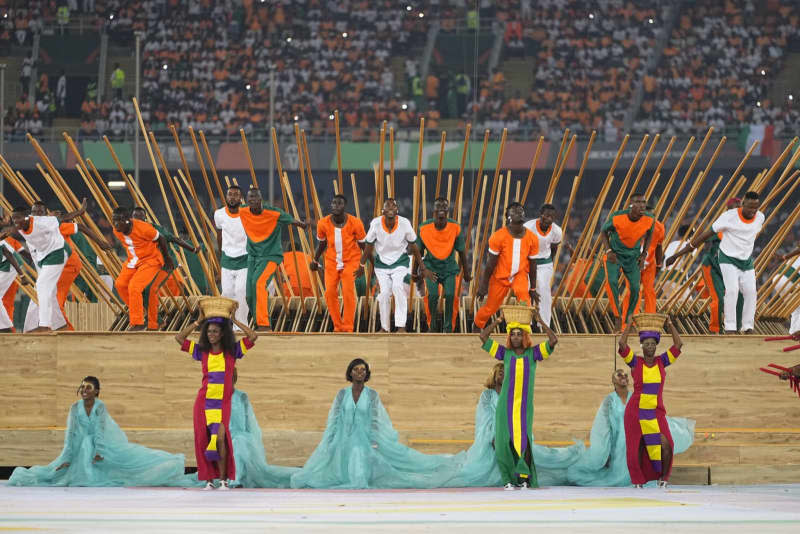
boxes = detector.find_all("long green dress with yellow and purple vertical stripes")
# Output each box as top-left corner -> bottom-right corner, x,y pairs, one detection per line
483,342 -> 553,488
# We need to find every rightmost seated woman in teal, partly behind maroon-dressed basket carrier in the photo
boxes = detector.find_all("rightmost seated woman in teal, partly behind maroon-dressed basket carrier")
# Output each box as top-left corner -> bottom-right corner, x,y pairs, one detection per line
567,369 -> 695,486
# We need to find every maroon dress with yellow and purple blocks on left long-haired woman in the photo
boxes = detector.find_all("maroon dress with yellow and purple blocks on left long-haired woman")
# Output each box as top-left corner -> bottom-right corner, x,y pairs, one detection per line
181,338 -> 253,480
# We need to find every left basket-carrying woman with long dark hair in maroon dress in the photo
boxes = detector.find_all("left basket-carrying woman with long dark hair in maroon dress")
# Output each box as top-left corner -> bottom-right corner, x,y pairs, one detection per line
175,312 -> 258,490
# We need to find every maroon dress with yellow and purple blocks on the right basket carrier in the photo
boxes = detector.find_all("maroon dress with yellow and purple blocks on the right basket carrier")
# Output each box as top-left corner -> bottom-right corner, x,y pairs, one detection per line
619,344 -> 681,484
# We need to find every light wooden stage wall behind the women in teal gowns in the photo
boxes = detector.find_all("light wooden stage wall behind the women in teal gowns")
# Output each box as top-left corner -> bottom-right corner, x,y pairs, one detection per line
0,332 -> 800,484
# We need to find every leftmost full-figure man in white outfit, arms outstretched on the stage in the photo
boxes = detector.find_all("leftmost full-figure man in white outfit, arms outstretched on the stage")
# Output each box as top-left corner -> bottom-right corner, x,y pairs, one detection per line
6,199 -> 86,332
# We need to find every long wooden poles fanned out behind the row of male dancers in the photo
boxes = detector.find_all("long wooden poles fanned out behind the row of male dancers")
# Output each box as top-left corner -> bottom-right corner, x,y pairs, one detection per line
0,109 -> 800,333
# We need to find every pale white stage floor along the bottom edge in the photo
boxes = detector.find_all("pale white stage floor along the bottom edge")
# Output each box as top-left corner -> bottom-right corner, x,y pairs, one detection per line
0,483 -> 800,534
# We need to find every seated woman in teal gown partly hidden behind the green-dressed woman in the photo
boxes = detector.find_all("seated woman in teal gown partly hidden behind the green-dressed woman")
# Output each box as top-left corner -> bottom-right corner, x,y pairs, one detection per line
447,362 -> 583,488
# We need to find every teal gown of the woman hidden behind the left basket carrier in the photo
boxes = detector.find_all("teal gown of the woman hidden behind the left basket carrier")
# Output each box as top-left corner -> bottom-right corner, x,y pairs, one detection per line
229,389 -> 300,488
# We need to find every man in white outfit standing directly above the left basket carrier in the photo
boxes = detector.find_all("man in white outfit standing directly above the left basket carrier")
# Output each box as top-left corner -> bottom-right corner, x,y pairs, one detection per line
214,185 -> 250,324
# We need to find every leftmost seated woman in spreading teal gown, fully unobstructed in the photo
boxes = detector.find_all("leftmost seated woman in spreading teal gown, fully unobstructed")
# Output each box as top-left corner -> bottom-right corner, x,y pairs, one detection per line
8,376 -> 197,486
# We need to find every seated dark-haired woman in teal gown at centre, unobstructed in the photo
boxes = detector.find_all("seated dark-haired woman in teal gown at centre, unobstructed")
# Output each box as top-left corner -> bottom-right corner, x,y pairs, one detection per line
291,358 -> 463,489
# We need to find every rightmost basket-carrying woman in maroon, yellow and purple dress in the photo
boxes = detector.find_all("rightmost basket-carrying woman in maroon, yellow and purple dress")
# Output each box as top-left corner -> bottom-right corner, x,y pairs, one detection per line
619,318 -> 683,488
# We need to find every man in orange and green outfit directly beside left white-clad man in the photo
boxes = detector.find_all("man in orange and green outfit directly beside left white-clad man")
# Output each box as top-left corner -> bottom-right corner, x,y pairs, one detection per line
239,188 -> 308,332
